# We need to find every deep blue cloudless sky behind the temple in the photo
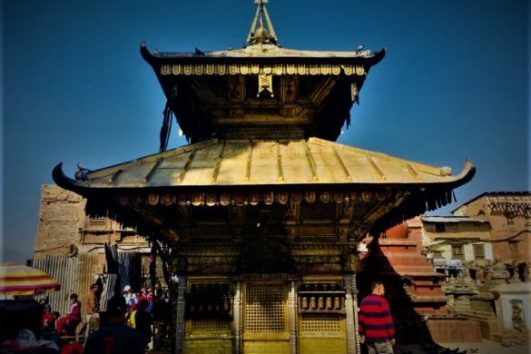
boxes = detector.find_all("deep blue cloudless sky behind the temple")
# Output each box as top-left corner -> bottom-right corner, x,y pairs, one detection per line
2,0 -> 531,261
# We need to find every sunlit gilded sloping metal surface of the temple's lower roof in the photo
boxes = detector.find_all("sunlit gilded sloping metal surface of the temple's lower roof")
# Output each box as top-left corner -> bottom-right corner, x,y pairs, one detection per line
58,138 -> 472,188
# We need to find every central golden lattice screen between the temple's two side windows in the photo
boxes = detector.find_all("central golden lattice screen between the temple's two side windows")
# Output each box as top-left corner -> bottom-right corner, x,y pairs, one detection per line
245,284 -> 287,332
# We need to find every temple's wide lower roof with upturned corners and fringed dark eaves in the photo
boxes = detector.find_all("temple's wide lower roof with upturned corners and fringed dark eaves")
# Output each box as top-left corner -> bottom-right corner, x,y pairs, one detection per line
53,138 -> 475,236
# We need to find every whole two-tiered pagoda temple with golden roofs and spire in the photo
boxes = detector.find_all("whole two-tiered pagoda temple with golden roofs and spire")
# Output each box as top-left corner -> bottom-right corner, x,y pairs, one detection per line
53,0 -> 475,354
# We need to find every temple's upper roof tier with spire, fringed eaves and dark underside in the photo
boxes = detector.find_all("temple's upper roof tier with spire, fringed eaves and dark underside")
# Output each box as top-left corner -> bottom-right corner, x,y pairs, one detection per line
140,0 -> 385,145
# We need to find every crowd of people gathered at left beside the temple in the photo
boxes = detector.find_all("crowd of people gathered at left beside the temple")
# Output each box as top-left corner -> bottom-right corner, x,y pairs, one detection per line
0,283 -> 166,354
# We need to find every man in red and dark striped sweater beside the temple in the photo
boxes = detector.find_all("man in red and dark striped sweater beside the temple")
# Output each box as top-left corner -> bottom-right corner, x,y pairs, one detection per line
358,281 -> 395,354
